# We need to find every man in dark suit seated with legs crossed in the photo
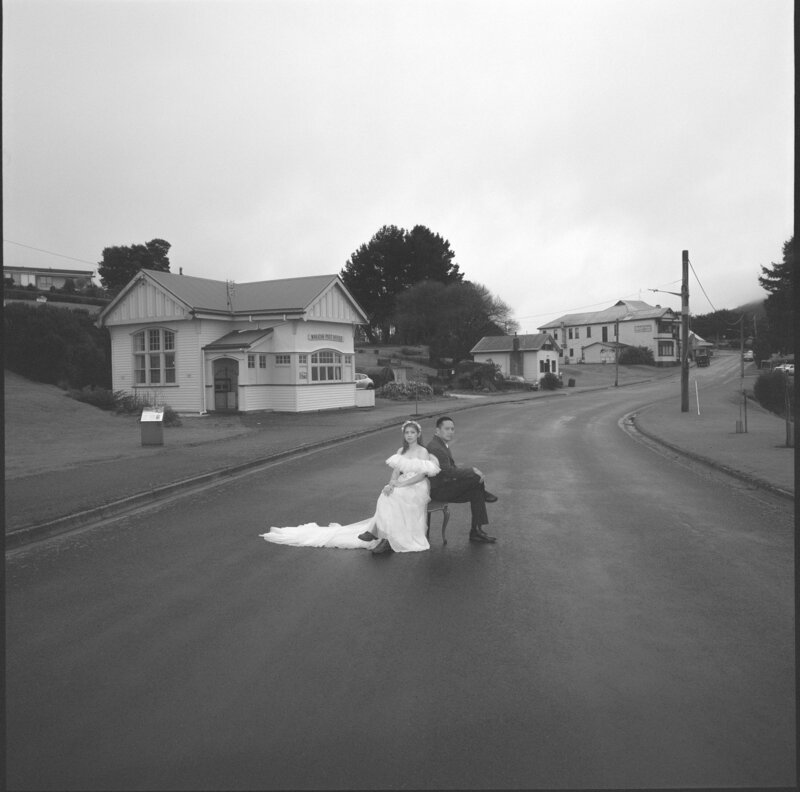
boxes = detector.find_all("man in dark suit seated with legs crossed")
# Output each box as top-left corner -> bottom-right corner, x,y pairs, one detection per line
427,415 -> 497,544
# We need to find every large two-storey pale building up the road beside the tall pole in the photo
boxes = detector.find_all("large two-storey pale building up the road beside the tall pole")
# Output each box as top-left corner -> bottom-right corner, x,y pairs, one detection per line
539,300 -> 681,366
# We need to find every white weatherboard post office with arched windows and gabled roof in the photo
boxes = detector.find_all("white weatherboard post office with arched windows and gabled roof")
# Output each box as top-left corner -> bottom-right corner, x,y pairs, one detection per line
97,270 -> 367,415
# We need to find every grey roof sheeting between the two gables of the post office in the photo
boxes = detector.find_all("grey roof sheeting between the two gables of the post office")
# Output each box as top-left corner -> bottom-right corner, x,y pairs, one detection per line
145,270 -> 338,313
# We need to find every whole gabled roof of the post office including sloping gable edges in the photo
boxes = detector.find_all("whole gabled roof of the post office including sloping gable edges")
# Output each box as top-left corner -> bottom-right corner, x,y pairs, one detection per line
98,269 -> 367,324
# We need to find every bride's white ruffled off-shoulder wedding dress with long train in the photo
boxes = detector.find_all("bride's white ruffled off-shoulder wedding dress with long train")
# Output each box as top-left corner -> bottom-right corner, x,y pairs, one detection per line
259,452 -> 439,553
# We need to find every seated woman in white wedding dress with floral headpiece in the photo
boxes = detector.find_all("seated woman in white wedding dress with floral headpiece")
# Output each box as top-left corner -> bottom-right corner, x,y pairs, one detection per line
260,421 -> 440,553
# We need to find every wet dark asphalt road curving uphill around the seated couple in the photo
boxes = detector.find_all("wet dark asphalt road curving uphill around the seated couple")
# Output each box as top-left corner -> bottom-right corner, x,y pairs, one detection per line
6,378 -> 795,790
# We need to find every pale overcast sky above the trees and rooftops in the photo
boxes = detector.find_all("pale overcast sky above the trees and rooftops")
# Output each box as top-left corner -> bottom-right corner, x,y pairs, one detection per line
3,0 -> 794,332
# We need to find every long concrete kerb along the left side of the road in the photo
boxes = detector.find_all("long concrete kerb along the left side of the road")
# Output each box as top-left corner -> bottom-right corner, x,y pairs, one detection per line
5,380 -> 683,550
